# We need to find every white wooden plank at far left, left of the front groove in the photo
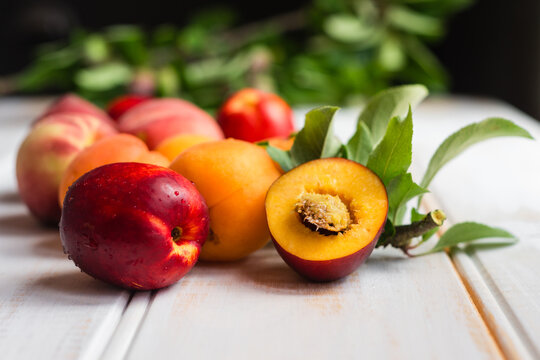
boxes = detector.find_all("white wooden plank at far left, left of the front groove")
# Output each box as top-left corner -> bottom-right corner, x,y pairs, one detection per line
0,100 -> 129,359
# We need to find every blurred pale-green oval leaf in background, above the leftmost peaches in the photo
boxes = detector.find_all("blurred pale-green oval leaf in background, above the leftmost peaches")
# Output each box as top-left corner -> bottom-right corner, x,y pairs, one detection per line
75,63 -> 133,91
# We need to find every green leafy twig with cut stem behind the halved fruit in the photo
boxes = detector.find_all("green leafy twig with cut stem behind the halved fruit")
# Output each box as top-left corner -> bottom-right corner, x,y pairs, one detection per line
260,85 -> 532,256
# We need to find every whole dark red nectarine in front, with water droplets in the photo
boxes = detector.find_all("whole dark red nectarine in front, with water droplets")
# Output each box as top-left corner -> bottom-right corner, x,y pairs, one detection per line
60,163 -> 208,290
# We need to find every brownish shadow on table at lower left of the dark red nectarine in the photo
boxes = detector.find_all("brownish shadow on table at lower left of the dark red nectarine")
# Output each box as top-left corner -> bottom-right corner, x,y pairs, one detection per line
30,270 -> 127,306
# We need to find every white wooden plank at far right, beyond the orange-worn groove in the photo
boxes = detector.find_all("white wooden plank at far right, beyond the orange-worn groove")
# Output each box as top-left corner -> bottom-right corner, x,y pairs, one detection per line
414,98 -> 540,359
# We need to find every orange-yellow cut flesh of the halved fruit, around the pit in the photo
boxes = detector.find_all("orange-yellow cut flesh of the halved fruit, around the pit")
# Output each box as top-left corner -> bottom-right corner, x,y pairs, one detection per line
266,158 -> 388,261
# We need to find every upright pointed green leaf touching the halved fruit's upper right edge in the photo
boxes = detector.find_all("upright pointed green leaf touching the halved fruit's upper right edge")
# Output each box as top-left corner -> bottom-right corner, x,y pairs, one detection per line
367,108 -> 413,186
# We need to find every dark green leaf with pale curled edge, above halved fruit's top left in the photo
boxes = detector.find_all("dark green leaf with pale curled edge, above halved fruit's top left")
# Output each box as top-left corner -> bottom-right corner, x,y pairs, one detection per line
291,106 -> 342,166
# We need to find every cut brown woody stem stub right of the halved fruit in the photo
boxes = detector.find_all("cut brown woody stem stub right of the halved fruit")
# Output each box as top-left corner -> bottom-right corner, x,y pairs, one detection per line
377,209 -> 446,256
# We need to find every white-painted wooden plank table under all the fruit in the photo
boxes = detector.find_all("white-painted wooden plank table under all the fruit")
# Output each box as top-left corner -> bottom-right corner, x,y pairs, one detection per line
0,97 -> 540,359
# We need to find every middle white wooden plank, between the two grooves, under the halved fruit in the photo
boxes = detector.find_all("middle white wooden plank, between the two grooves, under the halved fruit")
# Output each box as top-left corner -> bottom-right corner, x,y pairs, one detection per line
128,105 -> 501,359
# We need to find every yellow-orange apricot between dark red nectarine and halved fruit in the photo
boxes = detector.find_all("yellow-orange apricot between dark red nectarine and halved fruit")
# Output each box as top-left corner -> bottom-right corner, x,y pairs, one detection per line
170,139 -> 280,261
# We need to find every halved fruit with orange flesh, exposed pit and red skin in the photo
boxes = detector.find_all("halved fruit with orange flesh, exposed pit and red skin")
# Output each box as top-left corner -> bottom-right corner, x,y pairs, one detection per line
265,158 -> 388,281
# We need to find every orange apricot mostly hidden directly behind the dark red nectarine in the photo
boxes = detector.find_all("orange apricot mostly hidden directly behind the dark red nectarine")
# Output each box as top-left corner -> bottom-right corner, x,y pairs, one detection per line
58,134 -> 170,207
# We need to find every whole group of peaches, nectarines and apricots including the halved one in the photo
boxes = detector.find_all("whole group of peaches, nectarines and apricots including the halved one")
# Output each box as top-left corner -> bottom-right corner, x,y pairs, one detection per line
16,89 -> 388,290
